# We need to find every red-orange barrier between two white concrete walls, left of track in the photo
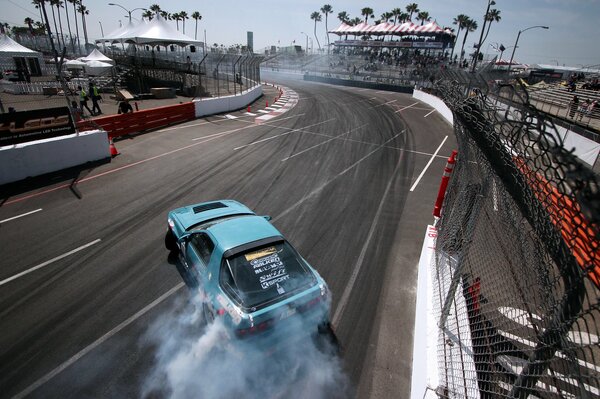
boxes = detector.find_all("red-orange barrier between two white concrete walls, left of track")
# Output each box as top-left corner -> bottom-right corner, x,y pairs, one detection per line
77,102 -> 196,138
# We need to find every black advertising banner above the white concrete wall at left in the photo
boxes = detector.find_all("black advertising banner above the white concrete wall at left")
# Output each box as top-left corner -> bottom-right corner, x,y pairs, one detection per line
0,107 -> 75,147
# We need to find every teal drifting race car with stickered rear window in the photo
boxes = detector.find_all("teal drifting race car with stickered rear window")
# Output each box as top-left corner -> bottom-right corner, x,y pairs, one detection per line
165,200 -> 337,346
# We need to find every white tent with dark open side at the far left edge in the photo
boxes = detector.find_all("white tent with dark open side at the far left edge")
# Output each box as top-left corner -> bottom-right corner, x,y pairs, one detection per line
0,34 -> 45,76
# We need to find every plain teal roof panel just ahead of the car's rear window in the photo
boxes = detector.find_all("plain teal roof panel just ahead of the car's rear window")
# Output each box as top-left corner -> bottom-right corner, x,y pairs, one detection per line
207,215 -> 281,252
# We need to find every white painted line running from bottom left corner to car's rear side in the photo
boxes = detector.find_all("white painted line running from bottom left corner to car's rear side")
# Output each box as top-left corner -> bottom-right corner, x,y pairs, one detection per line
13,282 -> 185,399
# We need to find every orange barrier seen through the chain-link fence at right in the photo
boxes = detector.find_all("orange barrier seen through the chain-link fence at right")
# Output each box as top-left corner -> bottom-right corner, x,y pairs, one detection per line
514,157 -> 600,288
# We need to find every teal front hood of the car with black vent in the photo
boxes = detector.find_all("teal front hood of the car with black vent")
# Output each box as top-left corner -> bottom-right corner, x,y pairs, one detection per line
170,200 -> 254,230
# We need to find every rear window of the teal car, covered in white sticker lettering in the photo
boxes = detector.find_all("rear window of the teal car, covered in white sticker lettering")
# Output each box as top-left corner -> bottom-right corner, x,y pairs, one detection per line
221,241 -> 316,309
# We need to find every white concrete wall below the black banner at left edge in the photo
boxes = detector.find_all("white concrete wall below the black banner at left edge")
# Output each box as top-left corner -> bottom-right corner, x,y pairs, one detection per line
0,130 -> 110,185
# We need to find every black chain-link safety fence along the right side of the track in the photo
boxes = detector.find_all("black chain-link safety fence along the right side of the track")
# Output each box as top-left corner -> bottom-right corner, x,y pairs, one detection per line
428,71 -> 600,398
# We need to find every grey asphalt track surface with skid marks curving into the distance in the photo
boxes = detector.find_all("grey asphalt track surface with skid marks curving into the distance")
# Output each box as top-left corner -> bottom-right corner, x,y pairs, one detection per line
0,76 -> 456,398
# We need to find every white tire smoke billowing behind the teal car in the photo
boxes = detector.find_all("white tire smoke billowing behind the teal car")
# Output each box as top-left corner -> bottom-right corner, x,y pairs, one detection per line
142,296 -> 351,399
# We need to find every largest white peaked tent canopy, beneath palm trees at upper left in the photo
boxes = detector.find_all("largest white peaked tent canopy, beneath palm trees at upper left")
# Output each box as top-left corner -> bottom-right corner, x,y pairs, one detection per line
96,16 -> 202,46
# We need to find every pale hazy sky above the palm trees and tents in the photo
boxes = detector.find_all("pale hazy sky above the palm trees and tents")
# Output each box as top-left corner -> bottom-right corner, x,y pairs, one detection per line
0,0 -> 600,67
